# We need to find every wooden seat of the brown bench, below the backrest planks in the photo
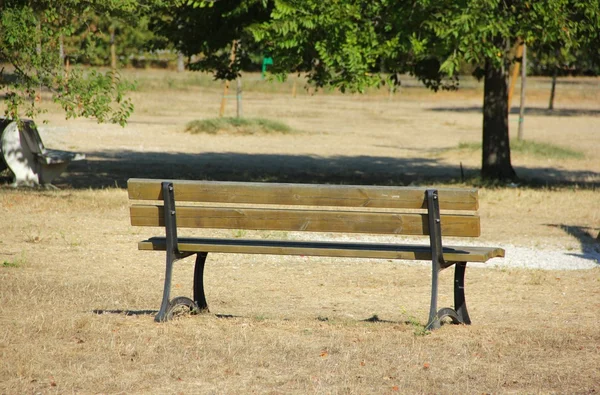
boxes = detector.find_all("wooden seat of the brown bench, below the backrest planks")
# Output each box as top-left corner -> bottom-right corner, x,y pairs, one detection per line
138,237 -> 504,262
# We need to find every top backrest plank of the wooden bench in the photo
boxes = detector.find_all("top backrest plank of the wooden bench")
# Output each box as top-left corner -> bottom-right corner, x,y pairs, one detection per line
127,178 -> 479,211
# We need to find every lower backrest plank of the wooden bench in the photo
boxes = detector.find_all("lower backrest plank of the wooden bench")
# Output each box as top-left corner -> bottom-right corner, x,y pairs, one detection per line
130,205 -> 480,237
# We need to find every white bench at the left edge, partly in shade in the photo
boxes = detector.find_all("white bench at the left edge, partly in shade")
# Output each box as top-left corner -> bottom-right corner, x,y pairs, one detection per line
0,118 -> 85,186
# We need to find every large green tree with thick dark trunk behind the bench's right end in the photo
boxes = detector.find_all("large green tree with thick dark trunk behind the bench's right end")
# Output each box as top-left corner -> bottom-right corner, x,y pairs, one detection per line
251,0 -> 600,179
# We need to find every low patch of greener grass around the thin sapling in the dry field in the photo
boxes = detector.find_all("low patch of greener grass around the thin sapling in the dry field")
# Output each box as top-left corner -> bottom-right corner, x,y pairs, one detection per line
185,118 -> 292,135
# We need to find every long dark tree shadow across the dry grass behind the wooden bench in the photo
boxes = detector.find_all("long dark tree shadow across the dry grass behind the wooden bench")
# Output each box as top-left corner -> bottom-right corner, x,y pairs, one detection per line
35,150 -> 600,189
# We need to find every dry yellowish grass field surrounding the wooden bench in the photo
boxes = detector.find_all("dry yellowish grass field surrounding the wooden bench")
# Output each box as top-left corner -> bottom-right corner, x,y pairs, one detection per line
0,70 -> 600,394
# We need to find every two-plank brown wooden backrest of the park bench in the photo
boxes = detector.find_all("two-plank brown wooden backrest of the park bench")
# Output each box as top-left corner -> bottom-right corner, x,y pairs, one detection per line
128,179 -> 480,237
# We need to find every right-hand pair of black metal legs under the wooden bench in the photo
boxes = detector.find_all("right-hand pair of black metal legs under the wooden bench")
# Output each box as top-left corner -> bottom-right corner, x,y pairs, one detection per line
425,262 -> 471,330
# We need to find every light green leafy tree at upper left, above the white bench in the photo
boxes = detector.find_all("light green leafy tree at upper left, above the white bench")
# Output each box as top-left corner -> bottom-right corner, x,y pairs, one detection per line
0,0 -> 140,124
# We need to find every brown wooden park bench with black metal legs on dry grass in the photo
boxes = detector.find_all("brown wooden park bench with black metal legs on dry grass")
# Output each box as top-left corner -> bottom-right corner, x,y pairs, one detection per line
128,179 -> 504,329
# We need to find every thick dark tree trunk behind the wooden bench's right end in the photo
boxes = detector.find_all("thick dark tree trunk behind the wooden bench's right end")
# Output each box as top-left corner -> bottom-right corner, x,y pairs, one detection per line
481,61 -> 516,180
